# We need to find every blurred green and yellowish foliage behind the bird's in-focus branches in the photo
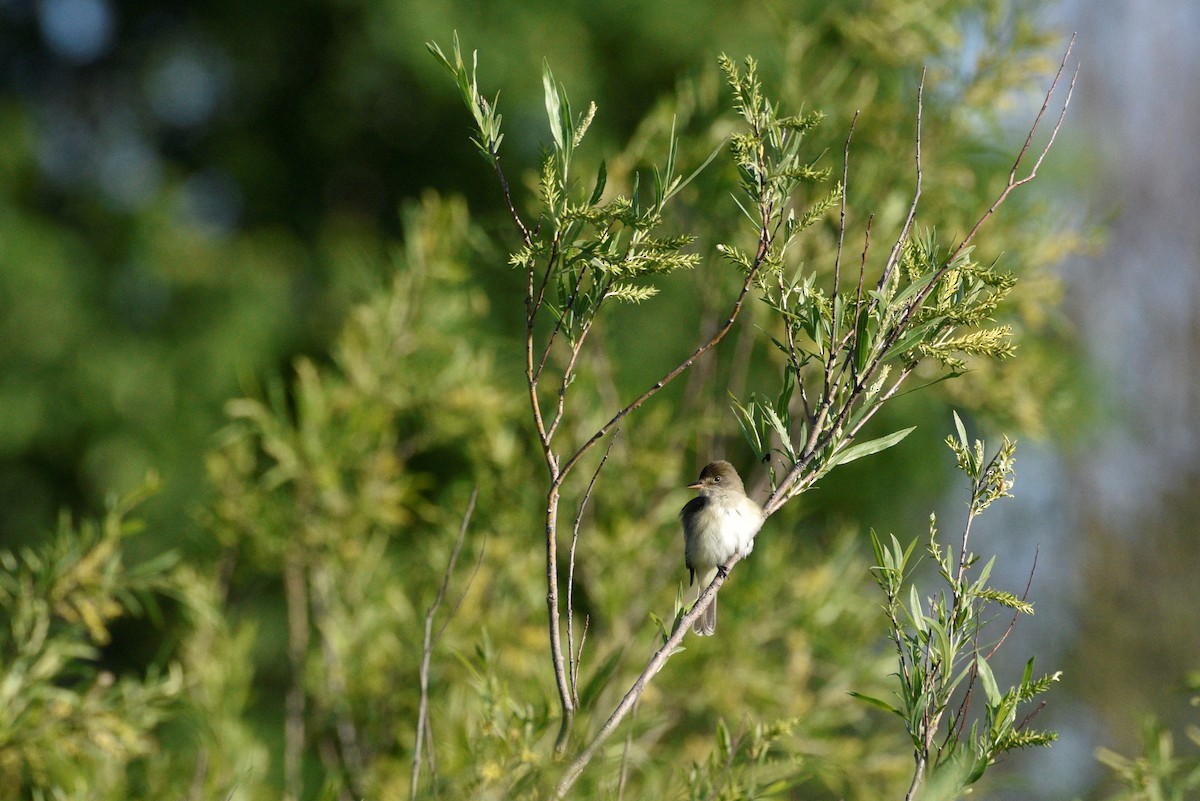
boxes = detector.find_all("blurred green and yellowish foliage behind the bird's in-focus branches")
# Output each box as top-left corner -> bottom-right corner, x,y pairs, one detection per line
0,0 -> 1079,799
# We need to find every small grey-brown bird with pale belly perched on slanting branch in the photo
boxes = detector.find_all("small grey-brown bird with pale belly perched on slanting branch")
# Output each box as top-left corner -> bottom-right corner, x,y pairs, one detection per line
679,460 -> 763,637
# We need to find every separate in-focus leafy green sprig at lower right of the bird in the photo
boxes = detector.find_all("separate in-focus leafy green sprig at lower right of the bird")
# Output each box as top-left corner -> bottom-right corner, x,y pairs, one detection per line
859,415 -> 1061,797
